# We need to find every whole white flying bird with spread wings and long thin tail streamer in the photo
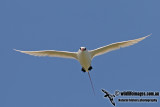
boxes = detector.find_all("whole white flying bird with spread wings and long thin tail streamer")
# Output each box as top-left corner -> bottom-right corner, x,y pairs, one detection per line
14,34 -> 151,94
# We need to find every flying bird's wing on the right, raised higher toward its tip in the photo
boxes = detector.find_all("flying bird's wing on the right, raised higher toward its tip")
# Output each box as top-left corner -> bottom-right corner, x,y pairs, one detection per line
89,34 -> 151,58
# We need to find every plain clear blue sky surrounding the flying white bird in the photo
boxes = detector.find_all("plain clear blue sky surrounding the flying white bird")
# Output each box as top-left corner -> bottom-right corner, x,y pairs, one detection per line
0,0 -> 160,107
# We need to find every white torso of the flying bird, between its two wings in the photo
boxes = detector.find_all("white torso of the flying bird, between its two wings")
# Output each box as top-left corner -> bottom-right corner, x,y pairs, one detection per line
77,50 -> 91,72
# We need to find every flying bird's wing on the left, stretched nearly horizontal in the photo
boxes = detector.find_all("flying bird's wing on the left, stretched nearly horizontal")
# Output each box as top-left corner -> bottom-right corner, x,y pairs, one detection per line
14,49 -> 77,59
